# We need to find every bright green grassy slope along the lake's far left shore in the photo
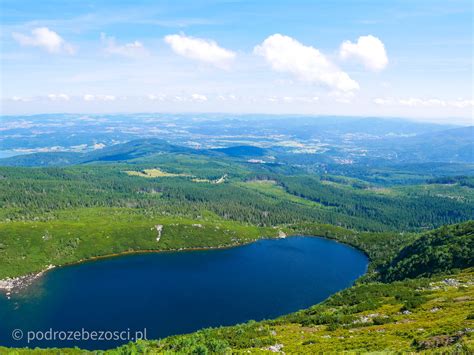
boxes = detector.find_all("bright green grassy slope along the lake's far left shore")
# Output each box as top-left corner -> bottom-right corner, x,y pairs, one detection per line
0,208 -> 278,279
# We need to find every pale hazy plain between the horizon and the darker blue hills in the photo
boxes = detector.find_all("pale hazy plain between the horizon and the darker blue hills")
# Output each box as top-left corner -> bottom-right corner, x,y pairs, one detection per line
0,113 -> 456,152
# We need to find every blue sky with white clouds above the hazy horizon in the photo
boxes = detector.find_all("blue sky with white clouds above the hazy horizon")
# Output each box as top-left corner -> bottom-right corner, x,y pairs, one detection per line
0,0 -> 474,125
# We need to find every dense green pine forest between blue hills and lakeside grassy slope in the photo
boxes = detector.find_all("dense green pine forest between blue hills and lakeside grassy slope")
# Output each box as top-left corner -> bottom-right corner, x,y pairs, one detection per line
0,155 -> 474,231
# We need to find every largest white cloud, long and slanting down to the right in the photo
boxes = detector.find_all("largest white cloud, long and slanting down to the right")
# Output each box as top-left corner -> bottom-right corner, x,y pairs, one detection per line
254,34 -> 359,91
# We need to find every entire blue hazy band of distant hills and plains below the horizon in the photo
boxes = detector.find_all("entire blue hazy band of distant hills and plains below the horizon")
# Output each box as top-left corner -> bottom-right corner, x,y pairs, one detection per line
0,114 -> 474,167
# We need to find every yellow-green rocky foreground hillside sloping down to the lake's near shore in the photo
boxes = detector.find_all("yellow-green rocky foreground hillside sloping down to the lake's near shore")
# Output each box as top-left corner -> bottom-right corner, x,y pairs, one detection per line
4,221 -> 474,354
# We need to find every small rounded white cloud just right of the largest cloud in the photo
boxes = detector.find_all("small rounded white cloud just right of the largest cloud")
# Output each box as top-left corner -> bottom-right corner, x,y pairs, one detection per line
339,35 -> 388,71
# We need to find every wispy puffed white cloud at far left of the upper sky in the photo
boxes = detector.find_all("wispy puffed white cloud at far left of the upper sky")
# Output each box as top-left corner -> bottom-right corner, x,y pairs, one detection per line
12,27 -> 74,54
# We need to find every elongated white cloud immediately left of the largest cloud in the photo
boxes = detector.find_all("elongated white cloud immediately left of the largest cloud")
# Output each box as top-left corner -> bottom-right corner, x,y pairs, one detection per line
164,34 -> 235,68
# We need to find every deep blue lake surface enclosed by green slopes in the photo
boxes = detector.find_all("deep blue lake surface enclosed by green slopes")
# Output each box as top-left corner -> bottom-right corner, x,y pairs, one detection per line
0,237 -> 368,349
